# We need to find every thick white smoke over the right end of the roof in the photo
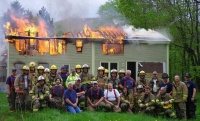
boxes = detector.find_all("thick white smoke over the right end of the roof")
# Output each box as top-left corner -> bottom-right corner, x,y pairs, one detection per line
123,26 -> 170,41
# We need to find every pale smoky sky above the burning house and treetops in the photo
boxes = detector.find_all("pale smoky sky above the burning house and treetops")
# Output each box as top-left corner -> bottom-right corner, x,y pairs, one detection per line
0,0 -> 108,21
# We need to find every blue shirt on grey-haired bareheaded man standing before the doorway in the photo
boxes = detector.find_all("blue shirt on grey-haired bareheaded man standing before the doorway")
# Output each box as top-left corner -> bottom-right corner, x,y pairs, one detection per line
119,77 -> 135,88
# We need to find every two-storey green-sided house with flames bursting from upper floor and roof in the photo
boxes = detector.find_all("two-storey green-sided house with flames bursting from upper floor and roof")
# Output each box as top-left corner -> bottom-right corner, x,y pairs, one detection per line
4,16 -> 170,81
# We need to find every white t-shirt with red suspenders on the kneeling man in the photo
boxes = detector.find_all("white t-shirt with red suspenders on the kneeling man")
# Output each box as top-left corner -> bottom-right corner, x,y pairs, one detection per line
104,89 -> 120,101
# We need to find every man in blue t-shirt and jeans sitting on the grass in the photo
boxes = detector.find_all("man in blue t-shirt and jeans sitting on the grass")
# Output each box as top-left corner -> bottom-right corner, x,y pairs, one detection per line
64,82 -> 81,114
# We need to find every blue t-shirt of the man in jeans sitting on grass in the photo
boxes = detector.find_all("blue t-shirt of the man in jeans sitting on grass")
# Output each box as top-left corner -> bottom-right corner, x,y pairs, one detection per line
64,89 -> 77,105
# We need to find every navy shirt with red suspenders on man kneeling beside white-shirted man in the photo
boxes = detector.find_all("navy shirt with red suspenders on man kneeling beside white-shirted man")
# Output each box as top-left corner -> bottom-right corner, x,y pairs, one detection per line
87,87 -> 104,99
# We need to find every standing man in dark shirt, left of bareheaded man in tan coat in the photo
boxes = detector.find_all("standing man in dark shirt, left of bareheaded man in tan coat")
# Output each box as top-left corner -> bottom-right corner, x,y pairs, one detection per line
161,73 -> 172,95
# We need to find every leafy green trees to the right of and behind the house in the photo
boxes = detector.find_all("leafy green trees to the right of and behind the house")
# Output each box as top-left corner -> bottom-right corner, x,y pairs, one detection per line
101,0 -> 200,89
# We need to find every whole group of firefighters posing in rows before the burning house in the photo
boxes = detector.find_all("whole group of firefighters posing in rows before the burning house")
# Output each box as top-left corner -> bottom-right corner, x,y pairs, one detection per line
6,62 -> 196,119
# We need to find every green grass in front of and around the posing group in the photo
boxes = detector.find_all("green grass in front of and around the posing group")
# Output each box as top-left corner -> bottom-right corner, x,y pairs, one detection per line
0,93 -> 200,121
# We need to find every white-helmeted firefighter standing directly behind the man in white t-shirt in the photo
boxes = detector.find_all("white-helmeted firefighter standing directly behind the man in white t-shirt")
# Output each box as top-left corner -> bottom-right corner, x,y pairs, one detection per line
105,69 -> 119,89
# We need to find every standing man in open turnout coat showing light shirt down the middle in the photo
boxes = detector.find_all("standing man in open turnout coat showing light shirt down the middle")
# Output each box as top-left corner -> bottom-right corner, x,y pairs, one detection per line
149,71 -> 163,96
